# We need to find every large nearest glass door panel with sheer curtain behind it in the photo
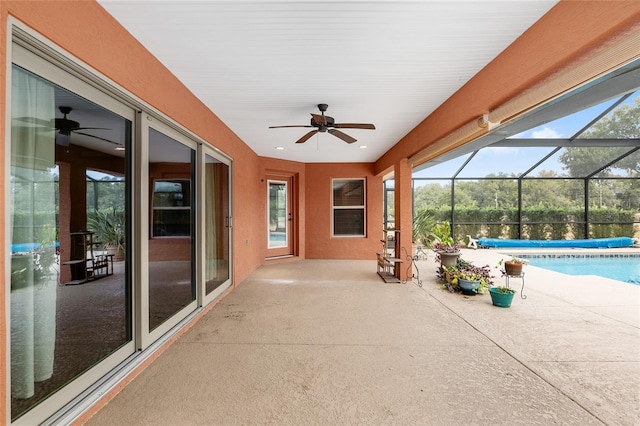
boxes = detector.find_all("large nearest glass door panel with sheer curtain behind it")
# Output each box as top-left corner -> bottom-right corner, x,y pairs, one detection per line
9,65 -> 135,419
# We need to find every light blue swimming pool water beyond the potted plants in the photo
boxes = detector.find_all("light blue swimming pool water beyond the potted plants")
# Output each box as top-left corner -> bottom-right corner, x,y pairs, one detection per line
516,253 -> 640,285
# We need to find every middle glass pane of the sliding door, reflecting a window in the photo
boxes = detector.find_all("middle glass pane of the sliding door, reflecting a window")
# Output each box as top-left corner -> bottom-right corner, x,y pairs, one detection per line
148,128 -> 196,331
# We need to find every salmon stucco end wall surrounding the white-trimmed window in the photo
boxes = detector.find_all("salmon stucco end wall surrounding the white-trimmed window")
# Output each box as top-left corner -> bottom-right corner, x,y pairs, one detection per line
305,163 -> 383,260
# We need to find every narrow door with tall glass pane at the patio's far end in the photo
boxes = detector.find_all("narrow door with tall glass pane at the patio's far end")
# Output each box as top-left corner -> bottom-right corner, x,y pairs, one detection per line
267,176 -> 294,257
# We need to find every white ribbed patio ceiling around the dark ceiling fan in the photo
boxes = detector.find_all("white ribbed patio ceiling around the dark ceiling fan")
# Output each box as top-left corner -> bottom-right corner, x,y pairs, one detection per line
98,0 -> 557,162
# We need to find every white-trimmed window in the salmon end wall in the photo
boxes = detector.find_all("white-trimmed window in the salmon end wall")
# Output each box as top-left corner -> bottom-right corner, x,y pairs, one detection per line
331,179 -> 366,237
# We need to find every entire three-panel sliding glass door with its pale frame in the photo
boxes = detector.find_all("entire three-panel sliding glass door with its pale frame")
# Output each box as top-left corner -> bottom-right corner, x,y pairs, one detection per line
9,29 -> 233,424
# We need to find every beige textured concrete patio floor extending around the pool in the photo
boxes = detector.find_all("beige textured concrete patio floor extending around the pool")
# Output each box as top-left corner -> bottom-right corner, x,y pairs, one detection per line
86,250 -> 640,426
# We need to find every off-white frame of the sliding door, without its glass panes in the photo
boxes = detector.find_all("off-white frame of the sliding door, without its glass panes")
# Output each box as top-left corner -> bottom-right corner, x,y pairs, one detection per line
3,16 -> 233,424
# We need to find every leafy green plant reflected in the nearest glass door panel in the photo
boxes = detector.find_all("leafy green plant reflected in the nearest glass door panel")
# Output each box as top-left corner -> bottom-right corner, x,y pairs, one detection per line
87,208 -> 125,261
